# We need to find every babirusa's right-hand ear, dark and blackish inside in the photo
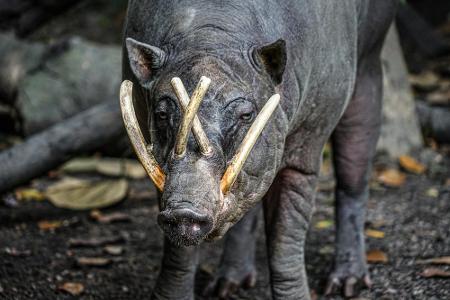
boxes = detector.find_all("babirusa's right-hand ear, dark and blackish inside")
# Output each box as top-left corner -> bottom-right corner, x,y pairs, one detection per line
254,39 -> 287,85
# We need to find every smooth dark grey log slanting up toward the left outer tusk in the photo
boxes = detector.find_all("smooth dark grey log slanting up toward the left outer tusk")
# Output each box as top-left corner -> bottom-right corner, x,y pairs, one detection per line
0,102 -> 125,193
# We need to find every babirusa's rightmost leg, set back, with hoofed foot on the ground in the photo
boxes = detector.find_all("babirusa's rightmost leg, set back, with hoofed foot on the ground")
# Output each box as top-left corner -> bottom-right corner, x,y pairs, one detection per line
326,55 -> 382,297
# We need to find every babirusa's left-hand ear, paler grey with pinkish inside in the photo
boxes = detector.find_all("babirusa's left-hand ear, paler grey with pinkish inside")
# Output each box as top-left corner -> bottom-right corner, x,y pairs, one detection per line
125,38 -> 167,85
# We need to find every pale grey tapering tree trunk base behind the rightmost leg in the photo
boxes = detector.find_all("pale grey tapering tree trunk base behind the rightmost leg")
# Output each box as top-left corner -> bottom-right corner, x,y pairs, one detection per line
378,26 -> 423,158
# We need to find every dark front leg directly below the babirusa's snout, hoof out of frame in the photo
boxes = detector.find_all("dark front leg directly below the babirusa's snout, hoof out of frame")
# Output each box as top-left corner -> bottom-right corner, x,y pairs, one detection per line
152,239 -> 198,300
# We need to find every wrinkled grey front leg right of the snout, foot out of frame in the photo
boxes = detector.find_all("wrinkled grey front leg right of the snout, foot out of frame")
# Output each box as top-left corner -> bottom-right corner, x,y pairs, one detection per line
264,169 -> 317,299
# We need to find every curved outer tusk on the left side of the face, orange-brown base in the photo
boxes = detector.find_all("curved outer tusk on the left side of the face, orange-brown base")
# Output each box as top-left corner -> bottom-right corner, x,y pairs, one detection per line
120,80 -> 166,192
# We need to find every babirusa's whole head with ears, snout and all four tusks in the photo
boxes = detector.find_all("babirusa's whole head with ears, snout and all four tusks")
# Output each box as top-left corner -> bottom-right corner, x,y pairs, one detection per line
121,38 -> 288,246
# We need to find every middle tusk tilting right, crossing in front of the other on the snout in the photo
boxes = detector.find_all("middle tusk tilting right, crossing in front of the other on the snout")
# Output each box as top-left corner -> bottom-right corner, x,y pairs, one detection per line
175,76 -> 211,157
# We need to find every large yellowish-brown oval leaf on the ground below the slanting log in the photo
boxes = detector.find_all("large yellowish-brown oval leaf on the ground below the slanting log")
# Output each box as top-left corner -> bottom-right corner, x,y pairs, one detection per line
45,178 -> 128,210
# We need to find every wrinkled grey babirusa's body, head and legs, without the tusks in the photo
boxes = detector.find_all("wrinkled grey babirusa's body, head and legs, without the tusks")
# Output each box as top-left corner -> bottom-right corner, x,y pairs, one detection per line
123,0 -> 396,299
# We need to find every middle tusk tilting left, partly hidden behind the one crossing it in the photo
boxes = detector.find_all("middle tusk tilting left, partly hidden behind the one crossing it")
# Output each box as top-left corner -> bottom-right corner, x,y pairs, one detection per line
170,77 -> 211,155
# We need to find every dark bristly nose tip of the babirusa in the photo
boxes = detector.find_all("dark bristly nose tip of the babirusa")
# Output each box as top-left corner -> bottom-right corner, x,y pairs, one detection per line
158,208 -> 213,246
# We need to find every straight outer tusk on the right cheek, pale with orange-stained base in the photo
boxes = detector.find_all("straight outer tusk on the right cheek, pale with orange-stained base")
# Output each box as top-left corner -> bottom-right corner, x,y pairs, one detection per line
220,94 -> 280,195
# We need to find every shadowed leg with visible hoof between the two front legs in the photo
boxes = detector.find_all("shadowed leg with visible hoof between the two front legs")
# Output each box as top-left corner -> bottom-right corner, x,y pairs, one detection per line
205,204 -> 261,299
